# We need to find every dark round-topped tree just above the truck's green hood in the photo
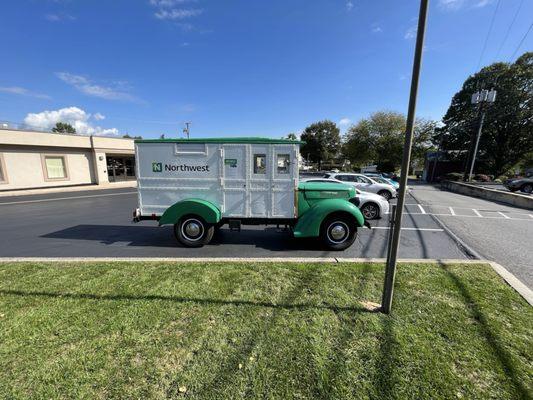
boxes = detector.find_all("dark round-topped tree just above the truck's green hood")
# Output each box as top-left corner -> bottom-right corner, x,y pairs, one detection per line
300,120 -> 341,169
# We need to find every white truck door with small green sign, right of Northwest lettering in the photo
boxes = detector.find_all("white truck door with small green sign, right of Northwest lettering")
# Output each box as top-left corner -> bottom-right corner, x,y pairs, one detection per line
222,144 -> 248,218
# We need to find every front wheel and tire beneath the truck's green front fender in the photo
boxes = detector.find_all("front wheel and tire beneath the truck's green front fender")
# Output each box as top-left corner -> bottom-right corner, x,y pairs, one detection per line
320,214 -> 357,250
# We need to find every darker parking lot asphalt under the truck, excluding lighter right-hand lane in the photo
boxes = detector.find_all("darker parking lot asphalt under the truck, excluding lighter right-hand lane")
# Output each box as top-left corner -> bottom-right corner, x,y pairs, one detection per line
0,189 -> 466,259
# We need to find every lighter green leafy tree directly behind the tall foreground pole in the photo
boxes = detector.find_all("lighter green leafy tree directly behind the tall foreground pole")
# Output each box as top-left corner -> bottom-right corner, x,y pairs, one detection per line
343,111 -> 436,172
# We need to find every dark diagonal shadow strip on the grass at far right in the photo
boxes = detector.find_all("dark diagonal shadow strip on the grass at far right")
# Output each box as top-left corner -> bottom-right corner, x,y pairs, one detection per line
441,264 -> 531,399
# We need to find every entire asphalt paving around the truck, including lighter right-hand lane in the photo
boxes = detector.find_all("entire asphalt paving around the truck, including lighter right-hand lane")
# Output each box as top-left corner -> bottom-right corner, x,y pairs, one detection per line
0,185 -> 533,287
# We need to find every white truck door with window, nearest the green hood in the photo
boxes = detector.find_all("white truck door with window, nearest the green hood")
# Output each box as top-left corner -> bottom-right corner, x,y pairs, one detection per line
271,145 -> 298,218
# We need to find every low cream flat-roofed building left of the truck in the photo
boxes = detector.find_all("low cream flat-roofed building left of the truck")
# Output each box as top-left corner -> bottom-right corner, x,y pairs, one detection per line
0,129 -> 135,191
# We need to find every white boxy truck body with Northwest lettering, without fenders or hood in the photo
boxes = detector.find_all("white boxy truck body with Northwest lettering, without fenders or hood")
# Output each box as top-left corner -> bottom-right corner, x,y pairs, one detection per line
135,138 -> 300,219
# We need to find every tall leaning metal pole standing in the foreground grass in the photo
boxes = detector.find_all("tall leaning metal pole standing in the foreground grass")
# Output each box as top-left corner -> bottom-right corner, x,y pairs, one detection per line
381,0 -> 429,314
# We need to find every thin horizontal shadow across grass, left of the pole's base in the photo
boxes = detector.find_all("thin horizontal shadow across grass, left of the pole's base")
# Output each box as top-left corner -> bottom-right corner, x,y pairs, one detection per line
0,290 -> 373,312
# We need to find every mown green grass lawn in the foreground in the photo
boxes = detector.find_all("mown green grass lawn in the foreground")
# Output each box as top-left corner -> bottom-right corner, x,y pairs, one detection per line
0,263 -> 533,400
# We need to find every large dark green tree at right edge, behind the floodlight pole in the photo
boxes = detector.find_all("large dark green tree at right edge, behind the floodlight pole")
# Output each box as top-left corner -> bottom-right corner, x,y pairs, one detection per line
438,52 -> 533,176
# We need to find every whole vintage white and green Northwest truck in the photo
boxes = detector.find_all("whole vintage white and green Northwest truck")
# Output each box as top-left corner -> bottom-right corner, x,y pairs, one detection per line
134,138 -> 364,250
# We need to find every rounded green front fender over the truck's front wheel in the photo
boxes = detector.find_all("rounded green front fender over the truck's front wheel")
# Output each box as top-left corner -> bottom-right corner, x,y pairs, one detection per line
294,199 -> 365,237
